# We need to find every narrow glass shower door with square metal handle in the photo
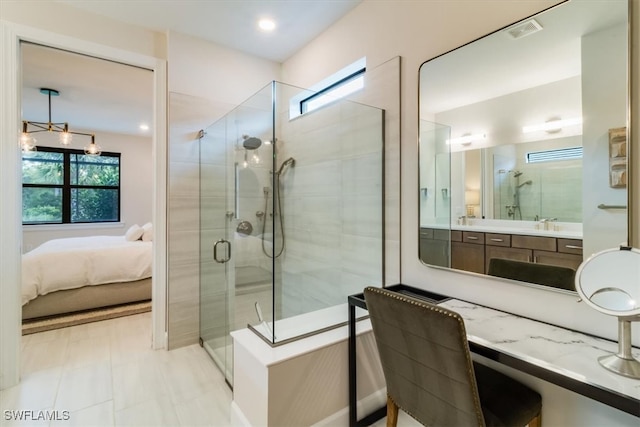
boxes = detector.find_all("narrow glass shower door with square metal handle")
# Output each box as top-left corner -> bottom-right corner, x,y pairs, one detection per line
199,120 -> 236,385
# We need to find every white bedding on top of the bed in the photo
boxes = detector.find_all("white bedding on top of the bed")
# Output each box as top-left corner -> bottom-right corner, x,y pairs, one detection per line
22,236 -> 152,305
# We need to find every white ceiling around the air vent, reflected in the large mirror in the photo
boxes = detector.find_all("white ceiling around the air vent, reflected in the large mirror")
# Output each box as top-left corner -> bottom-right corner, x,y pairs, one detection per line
420,0 -> 627,114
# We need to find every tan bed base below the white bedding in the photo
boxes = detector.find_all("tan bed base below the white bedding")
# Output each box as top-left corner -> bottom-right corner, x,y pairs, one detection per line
22,277 -> 151,320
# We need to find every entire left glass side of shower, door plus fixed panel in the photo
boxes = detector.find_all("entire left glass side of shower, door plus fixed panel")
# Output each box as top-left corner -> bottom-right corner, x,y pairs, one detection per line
199,86 -> 275,385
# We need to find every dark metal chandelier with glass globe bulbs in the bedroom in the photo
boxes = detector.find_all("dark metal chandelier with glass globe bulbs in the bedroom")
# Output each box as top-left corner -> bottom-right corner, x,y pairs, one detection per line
20,88 -> 102,156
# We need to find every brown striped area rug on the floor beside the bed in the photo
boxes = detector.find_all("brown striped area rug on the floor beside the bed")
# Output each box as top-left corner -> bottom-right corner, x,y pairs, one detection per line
22,301 -> 151,335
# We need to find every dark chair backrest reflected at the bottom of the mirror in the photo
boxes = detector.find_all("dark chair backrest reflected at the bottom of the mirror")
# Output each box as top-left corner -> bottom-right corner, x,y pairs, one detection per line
487,258 -> 576,291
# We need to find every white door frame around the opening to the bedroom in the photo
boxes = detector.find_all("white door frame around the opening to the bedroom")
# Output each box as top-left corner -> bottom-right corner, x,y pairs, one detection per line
0,21 -> 168,390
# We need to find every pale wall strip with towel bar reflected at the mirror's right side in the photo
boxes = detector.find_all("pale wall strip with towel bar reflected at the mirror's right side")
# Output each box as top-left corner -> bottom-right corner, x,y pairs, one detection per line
582,25 -> 628,254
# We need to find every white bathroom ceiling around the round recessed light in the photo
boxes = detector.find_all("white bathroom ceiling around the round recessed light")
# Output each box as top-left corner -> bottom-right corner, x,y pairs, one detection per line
56,0 -> 362,62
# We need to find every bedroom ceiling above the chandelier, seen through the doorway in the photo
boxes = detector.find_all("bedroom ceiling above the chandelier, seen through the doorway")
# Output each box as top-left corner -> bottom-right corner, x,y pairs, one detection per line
21,43 -> 153,141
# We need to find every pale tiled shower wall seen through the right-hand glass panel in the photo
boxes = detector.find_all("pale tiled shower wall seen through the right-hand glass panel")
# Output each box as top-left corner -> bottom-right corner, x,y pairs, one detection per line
276,83 -> 384,318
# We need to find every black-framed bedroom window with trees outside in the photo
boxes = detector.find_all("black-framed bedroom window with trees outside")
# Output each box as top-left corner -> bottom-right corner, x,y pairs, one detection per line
22,147 -> 120,225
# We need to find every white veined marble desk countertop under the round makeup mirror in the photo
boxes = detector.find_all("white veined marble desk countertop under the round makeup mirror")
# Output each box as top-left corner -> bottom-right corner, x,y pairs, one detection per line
438,299 -> 640,401
